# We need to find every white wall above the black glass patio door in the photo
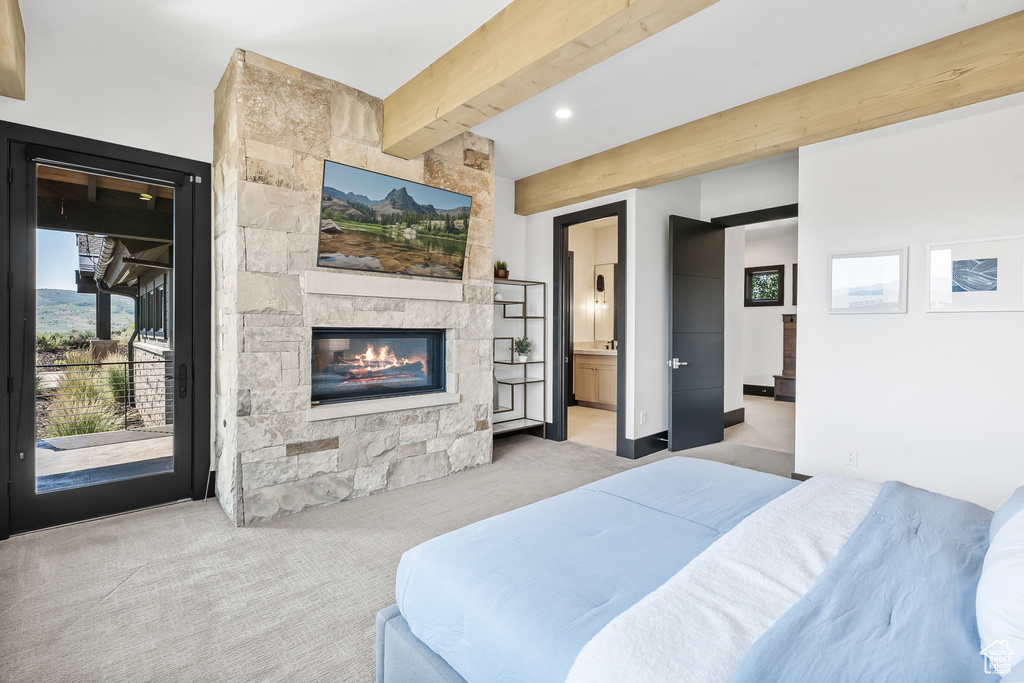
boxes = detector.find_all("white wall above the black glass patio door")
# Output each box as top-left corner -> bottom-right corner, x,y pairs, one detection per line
0,37 -> 214,162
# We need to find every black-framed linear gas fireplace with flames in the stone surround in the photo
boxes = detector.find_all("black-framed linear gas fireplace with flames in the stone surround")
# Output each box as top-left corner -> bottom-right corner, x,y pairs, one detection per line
312,328 -> 444,405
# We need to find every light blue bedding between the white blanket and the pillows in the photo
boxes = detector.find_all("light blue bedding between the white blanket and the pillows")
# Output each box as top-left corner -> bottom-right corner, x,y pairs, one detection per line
732,481 -> 999,683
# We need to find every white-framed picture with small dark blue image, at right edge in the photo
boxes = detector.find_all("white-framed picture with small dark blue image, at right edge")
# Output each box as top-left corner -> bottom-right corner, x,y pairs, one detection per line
928,234 -> 1024,312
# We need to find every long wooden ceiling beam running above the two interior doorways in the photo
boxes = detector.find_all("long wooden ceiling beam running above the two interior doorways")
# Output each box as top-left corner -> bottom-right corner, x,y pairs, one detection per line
515,11 -> 1024,215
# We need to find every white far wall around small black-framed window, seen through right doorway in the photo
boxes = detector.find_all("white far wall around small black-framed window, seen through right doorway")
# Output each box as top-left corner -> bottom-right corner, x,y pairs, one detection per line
740,233 -> 800,386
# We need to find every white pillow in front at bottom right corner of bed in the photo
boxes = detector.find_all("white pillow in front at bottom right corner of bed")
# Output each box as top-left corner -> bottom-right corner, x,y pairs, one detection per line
976,505 -> 1024,674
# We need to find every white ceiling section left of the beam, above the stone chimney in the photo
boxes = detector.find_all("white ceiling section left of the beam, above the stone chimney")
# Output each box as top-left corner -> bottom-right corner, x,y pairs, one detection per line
22,0 -> 520,101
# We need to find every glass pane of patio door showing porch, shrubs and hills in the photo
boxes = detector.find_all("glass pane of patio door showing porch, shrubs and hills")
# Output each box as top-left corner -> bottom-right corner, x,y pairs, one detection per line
35,165 -> 174,494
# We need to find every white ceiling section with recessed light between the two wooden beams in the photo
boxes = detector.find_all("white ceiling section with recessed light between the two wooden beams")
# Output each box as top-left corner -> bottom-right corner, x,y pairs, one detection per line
473,0 -> 1024,179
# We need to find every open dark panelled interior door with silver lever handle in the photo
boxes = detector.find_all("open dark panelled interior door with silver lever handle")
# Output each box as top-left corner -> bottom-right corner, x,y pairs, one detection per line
669,216 -> 725,451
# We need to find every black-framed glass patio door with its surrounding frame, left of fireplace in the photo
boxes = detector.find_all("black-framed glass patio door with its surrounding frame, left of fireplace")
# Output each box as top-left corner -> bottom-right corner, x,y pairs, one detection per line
0,124 -> 211,538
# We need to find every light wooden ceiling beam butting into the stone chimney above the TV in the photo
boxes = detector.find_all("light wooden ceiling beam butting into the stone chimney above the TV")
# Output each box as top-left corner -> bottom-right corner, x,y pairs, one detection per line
384,0 -> 718,159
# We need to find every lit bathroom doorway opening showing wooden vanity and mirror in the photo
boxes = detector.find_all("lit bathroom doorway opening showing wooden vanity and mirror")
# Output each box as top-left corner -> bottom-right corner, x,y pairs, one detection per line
566,216 -> 621,450
